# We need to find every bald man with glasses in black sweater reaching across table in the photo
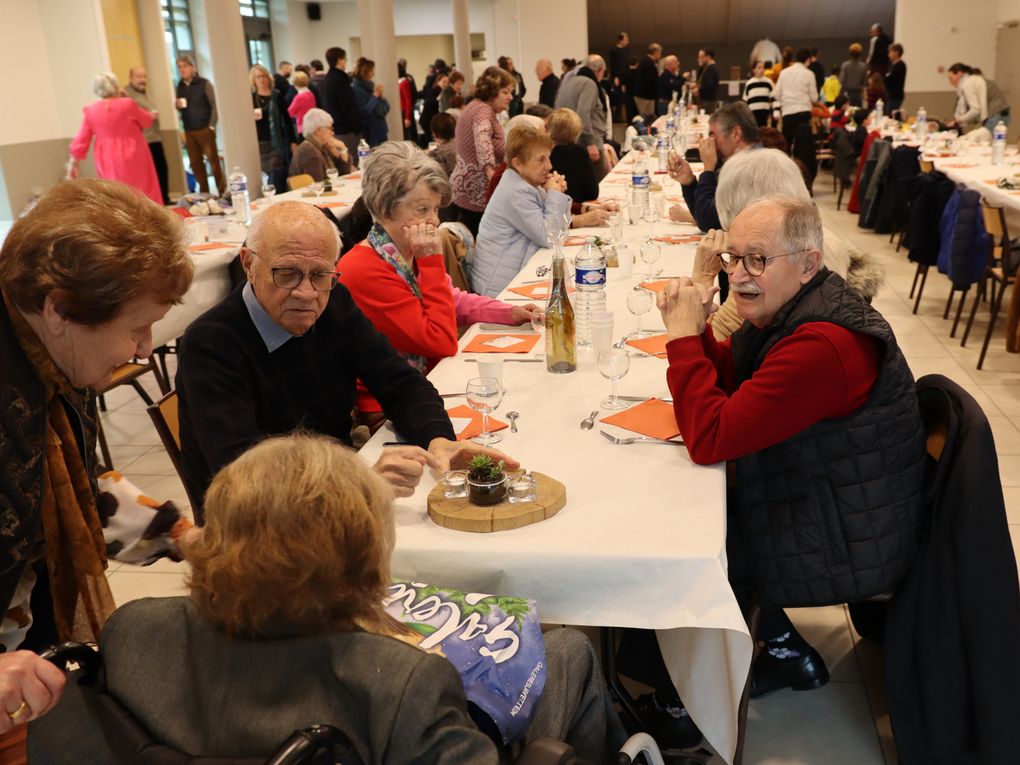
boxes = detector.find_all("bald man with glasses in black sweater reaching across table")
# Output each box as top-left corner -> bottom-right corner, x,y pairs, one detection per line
176,202 -> 517,521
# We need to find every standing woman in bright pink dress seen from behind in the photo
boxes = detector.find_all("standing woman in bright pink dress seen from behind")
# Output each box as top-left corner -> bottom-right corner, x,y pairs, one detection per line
67,71 -> 163,205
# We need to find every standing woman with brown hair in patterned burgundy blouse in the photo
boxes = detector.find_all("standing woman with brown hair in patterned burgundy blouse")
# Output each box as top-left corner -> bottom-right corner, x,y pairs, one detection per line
450,66 -> 514,237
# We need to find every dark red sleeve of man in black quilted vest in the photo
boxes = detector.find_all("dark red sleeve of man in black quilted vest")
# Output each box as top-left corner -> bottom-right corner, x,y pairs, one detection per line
666,322 -> 881,465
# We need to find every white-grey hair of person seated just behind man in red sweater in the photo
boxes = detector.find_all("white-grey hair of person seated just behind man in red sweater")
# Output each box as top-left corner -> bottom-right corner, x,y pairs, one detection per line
715,148 -> 811,228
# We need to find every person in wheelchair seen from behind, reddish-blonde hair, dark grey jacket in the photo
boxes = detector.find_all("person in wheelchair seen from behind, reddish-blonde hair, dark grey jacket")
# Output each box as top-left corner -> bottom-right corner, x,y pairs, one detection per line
100,434 -> 614,765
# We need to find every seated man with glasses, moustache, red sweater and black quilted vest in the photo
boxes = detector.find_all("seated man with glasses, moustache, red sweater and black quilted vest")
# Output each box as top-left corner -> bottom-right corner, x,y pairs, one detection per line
620,197 -> 925,730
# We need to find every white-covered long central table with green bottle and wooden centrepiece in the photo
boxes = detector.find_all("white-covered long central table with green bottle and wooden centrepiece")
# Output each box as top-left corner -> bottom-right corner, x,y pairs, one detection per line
363,160 -> 752,761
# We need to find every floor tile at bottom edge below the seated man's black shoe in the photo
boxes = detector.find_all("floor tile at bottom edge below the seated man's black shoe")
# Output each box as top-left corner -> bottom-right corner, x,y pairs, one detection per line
744,682 -> 884,765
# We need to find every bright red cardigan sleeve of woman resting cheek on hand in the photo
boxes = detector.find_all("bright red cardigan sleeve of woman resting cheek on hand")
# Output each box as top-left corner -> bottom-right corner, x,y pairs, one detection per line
340,244 -> 457,361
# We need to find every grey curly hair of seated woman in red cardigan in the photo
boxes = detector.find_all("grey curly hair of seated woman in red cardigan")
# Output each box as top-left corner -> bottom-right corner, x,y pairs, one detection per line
361,141 -> 453,221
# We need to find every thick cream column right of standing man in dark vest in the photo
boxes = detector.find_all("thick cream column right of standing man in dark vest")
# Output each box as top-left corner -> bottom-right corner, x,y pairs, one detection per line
191,0 -> 262,198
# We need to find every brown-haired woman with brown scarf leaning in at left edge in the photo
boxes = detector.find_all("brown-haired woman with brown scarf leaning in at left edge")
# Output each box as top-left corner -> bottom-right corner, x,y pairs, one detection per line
0,181 -> 193,762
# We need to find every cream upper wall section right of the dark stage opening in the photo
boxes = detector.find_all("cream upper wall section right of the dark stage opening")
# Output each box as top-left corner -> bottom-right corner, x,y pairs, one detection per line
896,0 -> 999,94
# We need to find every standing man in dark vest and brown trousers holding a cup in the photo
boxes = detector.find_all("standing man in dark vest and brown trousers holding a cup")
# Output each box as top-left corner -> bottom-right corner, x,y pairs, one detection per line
177,55 -> 226,196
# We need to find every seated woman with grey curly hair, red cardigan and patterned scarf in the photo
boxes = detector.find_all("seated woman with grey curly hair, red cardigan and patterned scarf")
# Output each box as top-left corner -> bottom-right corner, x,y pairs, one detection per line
340,141 -> 539,416
